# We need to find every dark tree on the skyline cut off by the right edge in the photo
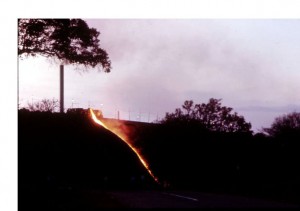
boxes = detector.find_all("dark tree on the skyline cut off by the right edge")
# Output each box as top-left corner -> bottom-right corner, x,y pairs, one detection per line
263,112 -> 300,137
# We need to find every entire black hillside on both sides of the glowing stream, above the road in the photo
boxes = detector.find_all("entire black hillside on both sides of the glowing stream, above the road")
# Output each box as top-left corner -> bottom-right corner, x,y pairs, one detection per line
18,101 -> 300,210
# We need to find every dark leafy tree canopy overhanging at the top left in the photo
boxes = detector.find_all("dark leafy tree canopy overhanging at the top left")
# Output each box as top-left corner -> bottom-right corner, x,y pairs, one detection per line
18,19 -> 111,72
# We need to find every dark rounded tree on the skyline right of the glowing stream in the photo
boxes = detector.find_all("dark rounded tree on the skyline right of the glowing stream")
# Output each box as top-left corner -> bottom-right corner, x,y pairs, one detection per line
161,98 -> 251,132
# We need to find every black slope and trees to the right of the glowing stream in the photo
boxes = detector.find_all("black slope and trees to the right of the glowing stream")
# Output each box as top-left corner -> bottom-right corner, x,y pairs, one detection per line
138,99 -> 300,203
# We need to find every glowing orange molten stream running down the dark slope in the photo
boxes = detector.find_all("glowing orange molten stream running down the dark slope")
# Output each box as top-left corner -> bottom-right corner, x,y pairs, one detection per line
90,109 -> 159,183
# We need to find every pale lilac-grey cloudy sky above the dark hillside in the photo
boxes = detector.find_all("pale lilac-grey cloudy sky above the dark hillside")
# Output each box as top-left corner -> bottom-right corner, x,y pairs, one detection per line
18,19 -> 300,131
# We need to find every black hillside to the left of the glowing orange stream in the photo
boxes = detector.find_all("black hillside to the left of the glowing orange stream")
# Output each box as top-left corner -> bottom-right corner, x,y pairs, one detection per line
18,110 -> 156,210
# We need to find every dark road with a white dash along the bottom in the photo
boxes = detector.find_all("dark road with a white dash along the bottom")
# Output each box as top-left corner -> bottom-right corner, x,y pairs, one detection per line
19,190 -> 300,211
